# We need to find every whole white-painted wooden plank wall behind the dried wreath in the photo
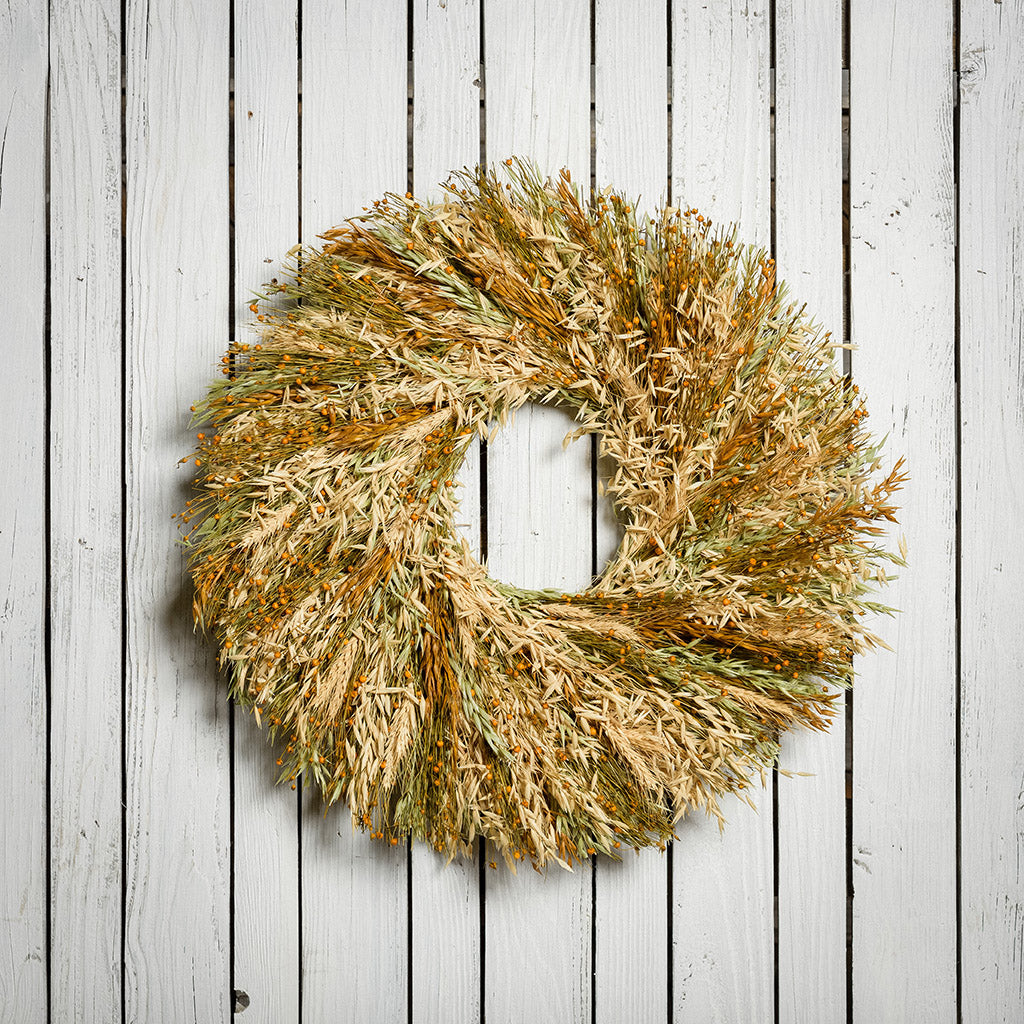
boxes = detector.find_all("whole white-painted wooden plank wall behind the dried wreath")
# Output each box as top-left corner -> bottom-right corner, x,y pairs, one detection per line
0,0 -> 1024,1024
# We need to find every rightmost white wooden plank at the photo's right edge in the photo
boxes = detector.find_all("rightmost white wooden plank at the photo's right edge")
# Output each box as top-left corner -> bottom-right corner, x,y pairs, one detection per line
958,0 -> 1024,1024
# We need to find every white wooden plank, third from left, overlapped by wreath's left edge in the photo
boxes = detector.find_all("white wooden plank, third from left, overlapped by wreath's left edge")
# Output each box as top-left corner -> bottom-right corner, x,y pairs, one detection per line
124,0 -> 231,1021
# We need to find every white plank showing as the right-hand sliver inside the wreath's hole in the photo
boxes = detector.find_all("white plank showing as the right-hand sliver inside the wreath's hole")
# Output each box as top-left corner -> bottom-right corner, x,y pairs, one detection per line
594,0 -> 669,1024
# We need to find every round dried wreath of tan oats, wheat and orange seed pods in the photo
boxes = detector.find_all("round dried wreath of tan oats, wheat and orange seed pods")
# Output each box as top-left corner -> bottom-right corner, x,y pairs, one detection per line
182,160 -> 904,867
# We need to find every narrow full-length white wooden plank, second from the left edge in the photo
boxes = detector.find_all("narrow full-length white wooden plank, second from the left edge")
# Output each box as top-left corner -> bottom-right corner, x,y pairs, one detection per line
50,0 -> 123,1021
